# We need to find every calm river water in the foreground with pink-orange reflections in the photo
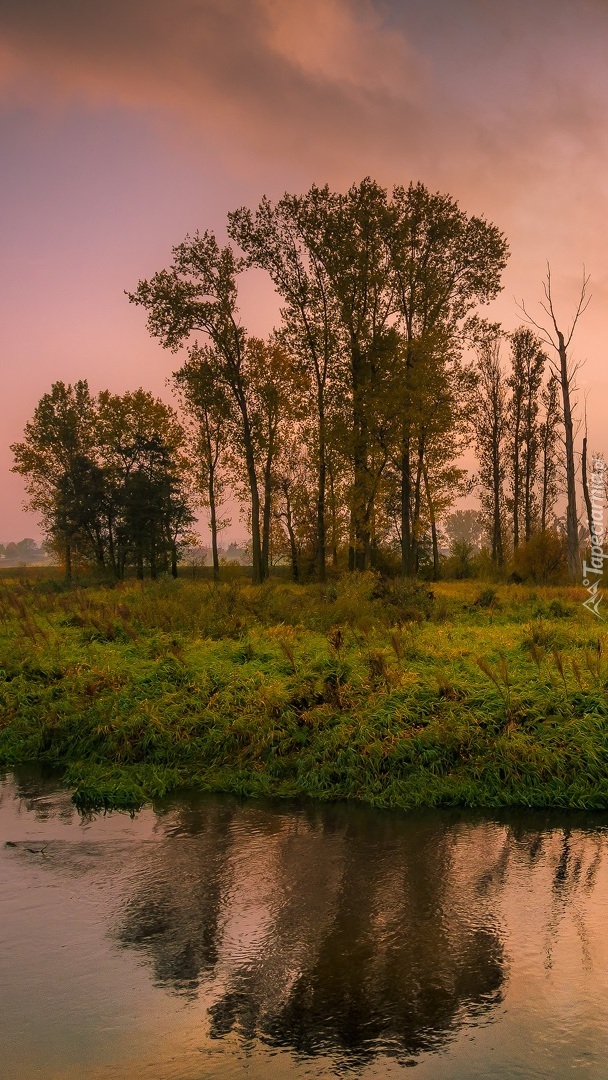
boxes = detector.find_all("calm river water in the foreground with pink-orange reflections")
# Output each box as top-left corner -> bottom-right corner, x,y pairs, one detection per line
0,772 -> 608,1080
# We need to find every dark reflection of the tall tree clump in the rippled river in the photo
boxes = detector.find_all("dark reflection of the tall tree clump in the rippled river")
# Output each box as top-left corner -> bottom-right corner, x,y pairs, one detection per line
112,799 -> 506,1067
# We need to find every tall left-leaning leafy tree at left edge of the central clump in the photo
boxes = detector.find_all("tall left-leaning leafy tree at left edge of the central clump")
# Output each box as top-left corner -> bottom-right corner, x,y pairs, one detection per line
127,232 -> 264,583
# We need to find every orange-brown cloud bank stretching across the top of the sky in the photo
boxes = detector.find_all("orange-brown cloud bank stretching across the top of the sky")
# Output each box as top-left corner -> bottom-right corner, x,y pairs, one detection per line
0,0 -> 608,205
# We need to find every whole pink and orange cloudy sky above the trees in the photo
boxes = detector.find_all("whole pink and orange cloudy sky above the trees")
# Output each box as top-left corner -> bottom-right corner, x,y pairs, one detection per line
0,0 -> 608,542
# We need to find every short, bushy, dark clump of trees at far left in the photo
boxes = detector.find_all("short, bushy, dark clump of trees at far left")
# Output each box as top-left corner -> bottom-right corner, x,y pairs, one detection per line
12,382 -> 193,579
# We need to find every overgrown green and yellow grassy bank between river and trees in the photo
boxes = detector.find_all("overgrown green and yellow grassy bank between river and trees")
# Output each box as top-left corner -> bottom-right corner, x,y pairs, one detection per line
0,576 -> 608,808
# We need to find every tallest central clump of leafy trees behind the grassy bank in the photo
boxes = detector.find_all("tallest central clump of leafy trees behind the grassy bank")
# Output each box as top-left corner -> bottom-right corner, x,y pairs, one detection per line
130,177 -> 508,581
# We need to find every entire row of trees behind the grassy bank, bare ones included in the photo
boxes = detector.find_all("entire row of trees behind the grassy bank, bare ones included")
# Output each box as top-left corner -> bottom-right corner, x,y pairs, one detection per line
13,179 -> 586,582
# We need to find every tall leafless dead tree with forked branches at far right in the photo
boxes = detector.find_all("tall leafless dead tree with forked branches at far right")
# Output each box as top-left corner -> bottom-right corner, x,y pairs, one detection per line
519,264 -> 591,579
